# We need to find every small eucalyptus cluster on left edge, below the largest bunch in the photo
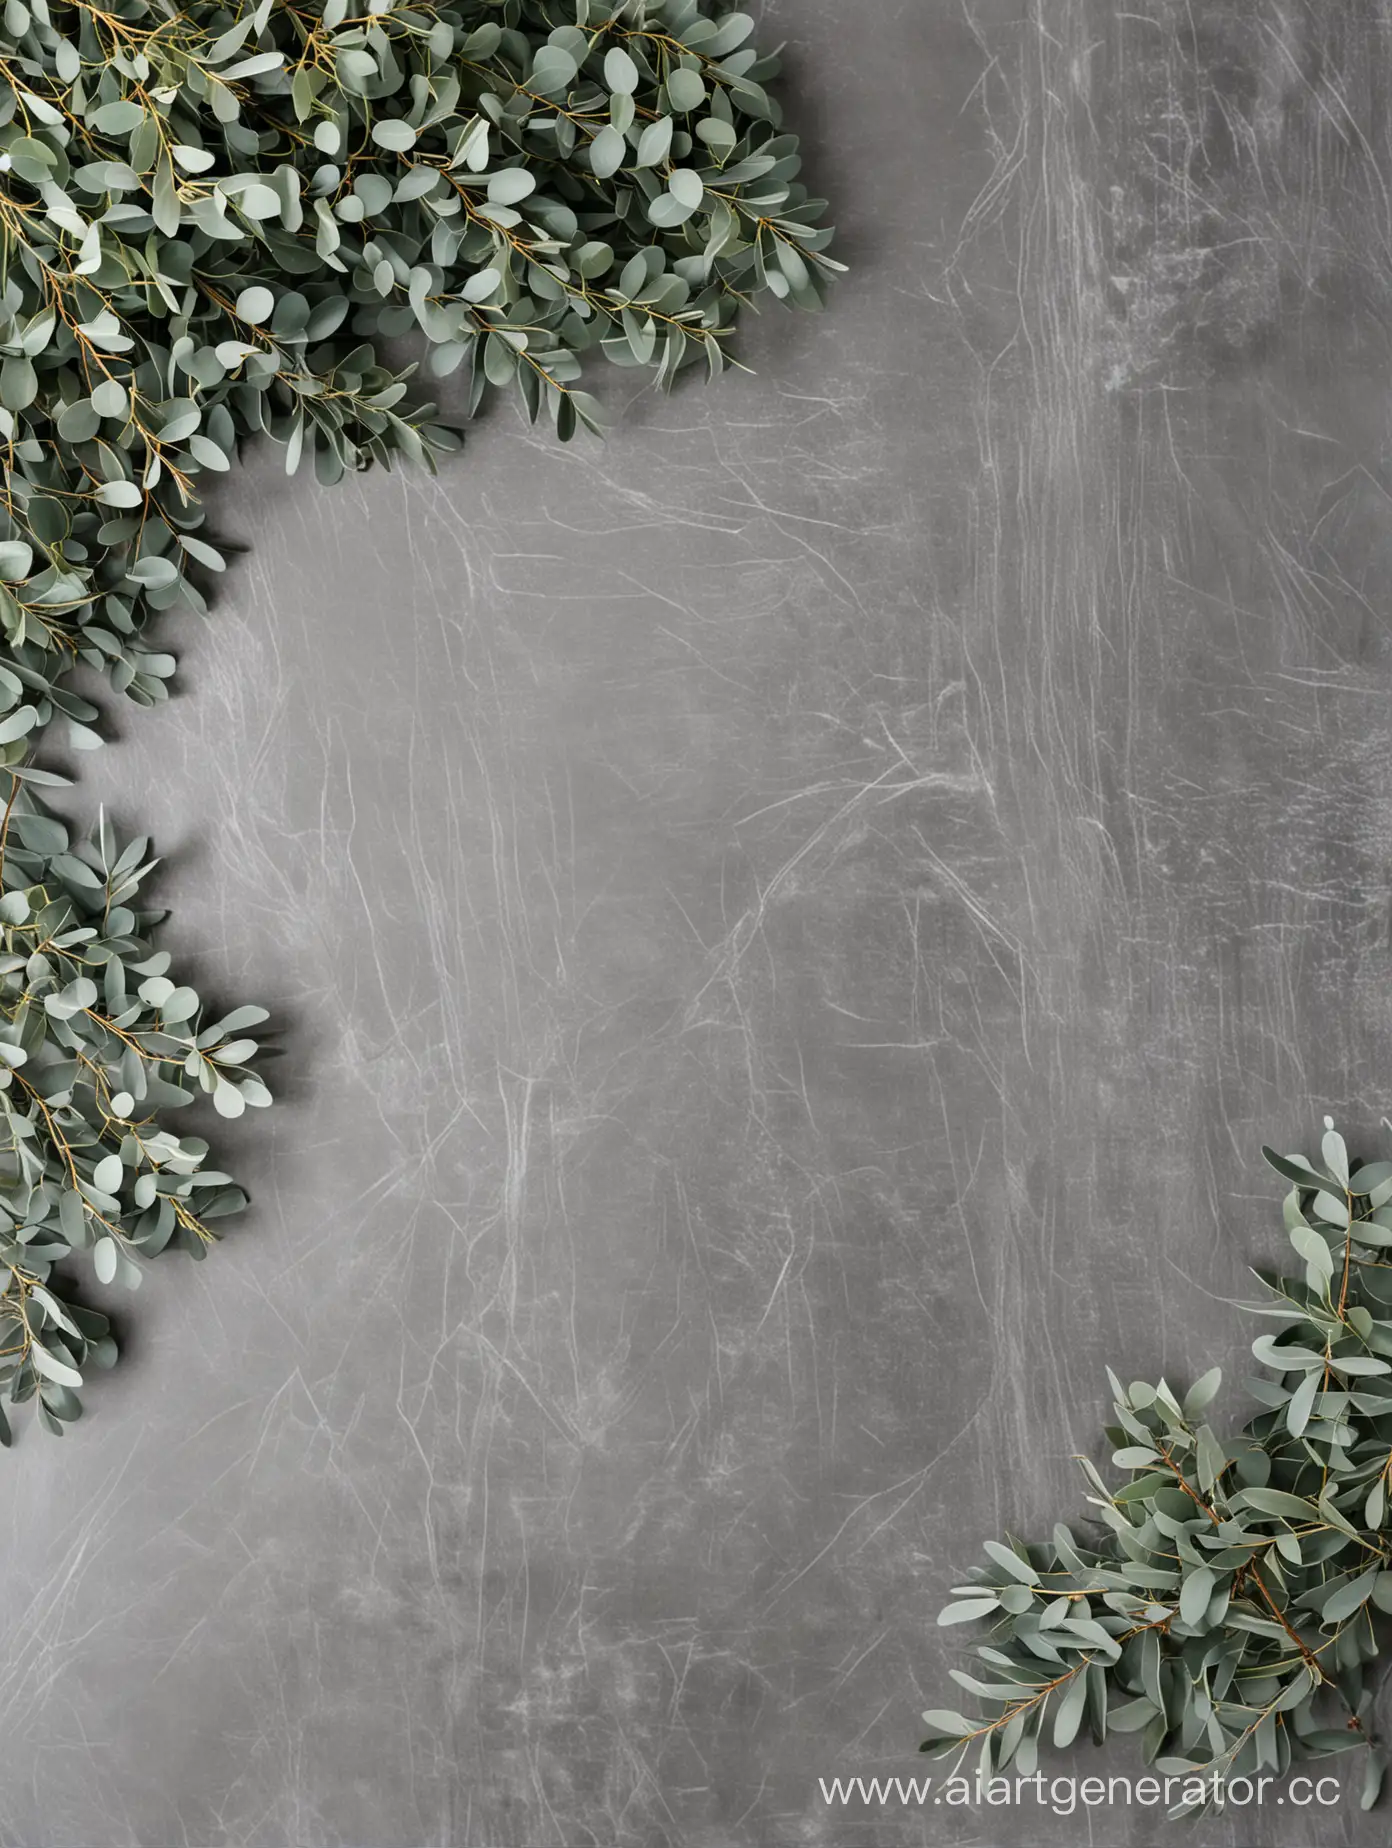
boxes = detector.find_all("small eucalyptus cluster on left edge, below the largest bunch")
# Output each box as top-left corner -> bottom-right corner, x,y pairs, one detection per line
0,782 -> 270,1445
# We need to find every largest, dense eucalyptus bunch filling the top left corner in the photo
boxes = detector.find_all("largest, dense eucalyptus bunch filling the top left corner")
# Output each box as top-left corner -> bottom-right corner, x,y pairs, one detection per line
0,0 -> 839,763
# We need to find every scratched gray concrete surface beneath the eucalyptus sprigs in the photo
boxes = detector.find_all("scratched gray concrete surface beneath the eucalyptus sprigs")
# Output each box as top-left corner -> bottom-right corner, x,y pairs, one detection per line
0,0 -> 1392,1848
